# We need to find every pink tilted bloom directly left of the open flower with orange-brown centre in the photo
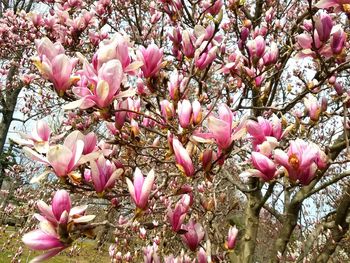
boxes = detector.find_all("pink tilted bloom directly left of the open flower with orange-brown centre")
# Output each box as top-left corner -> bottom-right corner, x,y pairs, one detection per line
248,152 -> 277,182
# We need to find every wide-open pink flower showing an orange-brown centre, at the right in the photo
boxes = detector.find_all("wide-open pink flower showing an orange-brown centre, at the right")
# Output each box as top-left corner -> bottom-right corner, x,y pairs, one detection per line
275,139 -> 321,185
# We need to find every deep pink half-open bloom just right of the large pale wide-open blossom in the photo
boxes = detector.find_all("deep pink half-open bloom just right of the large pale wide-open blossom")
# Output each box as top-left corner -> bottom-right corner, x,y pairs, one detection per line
90,155 -> 123,194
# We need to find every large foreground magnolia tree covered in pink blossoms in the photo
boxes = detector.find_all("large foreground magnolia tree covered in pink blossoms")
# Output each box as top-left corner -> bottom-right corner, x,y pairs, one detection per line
6,0 -> 350,263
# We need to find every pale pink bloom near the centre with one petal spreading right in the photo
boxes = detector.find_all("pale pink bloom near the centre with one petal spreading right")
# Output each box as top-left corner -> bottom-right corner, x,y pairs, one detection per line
208,104 -> 245,150
